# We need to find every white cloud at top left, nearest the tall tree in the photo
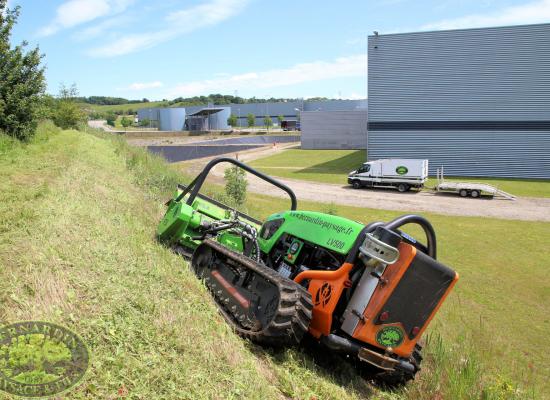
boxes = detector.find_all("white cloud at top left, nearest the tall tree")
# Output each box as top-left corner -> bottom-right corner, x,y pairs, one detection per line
38,0 -> 135,36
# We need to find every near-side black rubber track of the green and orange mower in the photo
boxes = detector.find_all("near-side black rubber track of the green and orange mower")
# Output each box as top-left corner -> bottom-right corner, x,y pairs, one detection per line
193,239 -> 313,346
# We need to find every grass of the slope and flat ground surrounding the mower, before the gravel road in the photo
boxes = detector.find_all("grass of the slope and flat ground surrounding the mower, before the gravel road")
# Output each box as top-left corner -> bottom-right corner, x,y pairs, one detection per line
0,124 -> 550,399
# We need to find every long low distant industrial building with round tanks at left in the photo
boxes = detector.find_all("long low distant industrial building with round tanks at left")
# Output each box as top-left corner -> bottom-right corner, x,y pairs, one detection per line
138,100 -> 367,133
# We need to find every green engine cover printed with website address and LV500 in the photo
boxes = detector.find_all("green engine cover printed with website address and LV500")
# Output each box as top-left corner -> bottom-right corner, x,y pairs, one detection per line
259,211 -> 365,254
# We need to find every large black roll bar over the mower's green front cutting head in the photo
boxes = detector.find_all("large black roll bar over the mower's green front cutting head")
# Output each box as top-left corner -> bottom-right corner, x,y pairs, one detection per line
175,157 -> 298,211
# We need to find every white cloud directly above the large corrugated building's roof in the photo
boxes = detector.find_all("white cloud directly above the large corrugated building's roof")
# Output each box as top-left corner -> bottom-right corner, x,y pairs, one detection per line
420,0 -> 550,30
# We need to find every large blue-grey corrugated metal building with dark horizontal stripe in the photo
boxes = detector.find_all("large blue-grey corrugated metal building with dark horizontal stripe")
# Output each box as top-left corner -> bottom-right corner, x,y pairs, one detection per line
368,24 -> 550,178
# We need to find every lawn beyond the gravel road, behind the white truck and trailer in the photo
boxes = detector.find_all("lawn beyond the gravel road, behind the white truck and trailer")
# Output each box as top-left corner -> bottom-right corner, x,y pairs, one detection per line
252,149 -> 550,197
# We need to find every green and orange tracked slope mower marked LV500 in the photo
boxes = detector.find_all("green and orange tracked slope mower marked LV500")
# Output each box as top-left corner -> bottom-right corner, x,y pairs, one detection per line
157,158 -> 458,384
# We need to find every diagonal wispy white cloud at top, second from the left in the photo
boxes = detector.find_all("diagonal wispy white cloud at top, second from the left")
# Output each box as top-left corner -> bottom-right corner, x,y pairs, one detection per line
88,0 -> 249,57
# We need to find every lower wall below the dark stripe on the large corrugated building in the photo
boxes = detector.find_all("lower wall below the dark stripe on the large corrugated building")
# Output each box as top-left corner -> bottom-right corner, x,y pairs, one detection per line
368,131 -> 550,179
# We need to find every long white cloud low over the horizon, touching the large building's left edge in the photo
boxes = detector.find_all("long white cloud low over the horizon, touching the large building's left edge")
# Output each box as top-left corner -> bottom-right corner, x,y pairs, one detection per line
167,54 -> 367,97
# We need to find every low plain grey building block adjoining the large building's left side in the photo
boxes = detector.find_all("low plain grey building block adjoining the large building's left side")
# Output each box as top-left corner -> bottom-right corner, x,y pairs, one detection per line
300,110 -> 367,149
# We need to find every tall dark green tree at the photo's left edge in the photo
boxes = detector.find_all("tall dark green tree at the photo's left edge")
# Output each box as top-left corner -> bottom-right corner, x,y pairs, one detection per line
0,0 -> 46,140
